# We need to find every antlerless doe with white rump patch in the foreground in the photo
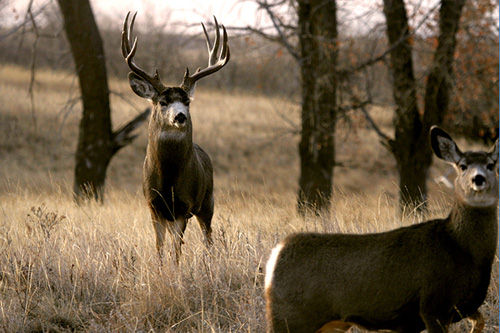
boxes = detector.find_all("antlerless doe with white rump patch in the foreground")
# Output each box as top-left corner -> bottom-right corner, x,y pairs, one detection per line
265,127 -> 498,333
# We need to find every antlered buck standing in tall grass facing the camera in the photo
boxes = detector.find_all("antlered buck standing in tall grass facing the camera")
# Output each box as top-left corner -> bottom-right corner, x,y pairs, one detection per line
121,12 -> 230,263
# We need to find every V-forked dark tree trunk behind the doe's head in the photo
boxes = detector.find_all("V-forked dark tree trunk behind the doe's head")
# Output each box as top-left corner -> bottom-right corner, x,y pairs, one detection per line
384,0 -> 464,211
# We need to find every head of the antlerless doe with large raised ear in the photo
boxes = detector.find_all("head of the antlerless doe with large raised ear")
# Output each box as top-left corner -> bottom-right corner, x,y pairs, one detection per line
430,126 -> 498,207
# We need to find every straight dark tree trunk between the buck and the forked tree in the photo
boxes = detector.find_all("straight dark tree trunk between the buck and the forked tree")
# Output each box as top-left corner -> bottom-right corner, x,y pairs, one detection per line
298,0 -> 337,214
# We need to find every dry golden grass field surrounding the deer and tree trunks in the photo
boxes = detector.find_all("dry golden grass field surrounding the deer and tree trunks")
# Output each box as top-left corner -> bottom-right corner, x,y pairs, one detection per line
0,66 -> 498,332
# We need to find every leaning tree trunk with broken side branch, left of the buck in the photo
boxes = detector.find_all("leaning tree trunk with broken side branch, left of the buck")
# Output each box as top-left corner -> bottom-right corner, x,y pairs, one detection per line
58,0 -> 149,201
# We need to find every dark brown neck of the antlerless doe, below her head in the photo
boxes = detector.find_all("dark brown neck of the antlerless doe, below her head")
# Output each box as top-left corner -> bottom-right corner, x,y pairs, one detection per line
448,202 -> 498,265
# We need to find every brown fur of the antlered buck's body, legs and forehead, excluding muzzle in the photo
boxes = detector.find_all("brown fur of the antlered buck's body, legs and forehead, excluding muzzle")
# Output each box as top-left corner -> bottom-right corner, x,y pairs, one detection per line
143,87 -> 214,261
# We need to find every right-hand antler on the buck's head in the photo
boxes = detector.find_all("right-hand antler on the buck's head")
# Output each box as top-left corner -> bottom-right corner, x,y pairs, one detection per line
181,16 -> 230,91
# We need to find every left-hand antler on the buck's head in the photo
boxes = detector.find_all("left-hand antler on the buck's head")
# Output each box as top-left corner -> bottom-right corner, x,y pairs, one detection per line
122,12 -> 165,92
